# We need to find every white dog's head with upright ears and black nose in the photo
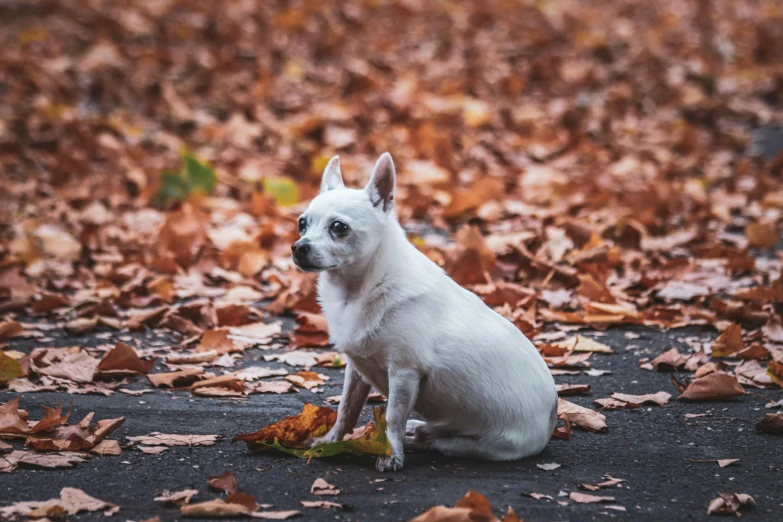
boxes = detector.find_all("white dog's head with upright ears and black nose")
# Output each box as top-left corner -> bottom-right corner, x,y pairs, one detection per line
291,152 -> 396,272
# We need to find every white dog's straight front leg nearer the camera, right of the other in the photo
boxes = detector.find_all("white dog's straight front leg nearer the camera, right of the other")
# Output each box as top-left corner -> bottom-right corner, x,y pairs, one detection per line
375,368 -> 421,471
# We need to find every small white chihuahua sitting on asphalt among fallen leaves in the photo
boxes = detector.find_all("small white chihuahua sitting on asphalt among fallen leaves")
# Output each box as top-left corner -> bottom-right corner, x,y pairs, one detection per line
292,153 -> 557,471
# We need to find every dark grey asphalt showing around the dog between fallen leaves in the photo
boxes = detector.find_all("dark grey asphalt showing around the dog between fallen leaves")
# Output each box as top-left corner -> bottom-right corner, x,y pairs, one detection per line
0,318 -> 783,520
